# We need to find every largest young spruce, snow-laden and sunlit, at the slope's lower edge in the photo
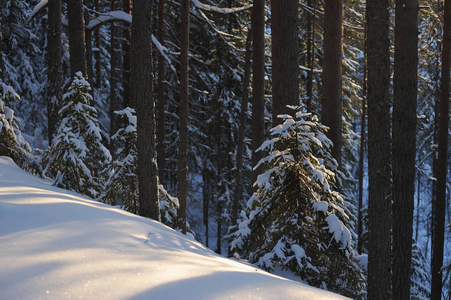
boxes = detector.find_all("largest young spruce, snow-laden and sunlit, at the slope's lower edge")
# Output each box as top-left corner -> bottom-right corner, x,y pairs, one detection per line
229,108 -> 365,298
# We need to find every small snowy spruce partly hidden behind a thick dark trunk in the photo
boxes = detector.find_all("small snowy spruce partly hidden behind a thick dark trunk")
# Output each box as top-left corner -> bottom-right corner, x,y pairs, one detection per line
99,107 -> 178,228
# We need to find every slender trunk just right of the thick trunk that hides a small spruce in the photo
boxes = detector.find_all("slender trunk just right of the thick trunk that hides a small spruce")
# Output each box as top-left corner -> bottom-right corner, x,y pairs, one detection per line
157,0 -> 166,184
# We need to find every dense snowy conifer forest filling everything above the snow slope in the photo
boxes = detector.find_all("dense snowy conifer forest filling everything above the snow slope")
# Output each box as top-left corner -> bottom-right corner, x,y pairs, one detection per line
0,0 -> 451,299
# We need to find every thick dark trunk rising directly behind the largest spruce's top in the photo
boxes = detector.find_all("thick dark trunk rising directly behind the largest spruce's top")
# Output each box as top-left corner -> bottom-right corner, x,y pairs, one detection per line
271,0 -> 300,125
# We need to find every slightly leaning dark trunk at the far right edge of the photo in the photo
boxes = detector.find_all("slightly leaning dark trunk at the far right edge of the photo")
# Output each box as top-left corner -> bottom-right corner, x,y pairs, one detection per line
431,0 -> 451,300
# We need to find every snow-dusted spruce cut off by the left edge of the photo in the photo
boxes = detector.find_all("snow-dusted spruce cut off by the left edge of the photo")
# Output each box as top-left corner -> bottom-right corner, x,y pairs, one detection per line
0,80 -> 39,173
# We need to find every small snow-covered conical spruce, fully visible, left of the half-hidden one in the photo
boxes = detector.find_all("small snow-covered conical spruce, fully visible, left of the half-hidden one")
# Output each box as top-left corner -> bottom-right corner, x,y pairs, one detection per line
44,72 -> 111,196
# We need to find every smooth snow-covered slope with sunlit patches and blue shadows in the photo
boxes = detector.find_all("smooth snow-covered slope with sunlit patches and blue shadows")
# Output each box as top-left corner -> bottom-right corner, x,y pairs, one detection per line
0,157 -> 350,300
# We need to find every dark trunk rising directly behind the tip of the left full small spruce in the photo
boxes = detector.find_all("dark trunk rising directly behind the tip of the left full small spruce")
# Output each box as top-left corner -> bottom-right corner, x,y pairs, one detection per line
67,0 -> 87,77
